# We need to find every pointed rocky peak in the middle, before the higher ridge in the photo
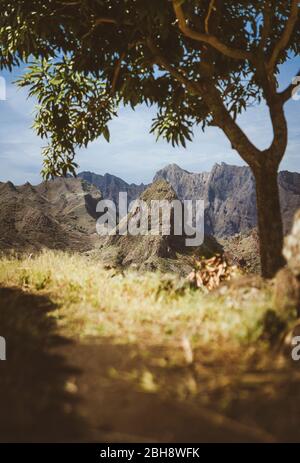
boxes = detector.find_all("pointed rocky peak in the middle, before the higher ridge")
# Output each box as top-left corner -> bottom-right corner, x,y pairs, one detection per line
96,180 -> 222,274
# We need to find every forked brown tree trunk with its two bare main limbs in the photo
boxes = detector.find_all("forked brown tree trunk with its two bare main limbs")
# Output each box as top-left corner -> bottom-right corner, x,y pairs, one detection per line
198,79 -> 288,278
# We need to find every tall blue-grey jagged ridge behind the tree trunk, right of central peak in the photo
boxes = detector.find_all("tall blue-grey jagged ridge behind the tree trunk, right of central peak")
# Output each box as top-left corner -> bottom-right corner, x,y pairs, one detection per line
154,163 -> 300,238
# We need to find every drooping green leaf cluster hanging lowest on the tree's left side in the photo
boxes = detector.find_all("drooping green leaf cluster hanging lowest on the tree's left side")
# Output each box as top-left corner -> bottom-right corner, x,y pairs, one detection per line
19,58 -> 115,179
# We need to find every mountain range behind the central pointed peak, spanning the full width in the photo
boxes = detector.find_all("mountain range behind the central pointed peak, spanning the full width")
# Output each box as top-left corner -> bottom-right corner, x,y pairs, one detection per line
0,163 -> 300,258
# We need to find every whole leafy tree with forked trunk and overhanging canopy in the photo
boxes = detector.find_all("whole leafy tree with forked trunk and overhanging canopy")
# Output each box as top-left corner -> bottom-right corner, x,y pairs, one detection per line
0,0 -> 300,277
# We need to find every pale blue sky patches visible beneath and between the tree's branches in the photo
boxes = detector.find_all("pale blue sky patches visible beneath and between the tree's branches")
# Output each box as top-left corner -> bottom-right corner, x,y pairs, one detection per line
0,57 -> 300,184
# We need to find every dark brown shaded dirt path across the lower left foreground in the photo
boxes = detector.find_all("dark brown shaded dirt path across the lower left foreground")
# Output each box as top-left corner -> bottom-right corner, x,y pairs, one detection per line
0,288 -> 272,442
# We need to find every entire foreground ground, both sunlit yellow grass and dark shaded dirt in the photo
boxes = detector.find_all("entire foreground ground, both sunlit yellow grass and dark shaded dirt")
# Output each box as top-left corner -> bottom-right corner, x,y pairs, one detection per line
0,251 -> 300,442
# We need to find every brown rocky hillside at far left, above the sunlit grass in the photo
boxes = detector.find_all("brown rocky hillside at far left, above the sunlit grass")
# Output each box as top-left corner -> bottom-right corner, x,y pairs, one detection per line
0,178 -> 101,251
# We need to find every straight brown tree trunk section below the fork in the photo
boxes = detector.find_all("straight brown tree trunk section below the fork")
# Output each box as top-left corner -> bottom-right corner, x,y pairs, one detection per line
254,165 -> 285,278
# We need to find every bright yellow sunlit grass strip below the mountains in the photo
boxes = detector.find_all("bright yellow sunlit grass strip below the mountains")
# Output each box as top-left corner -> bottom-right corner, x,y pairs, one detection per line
0,251 -> 282,347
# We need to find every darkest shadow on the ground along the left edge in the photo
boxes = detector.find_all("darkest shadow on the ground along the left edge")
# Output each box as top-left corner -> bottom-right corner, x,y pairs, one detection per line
0,288 -> 85,442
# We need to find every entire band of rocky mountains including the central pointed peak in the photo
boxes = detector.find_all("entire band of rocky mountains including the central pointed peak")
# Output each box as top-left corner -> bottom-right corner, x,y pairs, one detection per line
0,163 -> 300,271
